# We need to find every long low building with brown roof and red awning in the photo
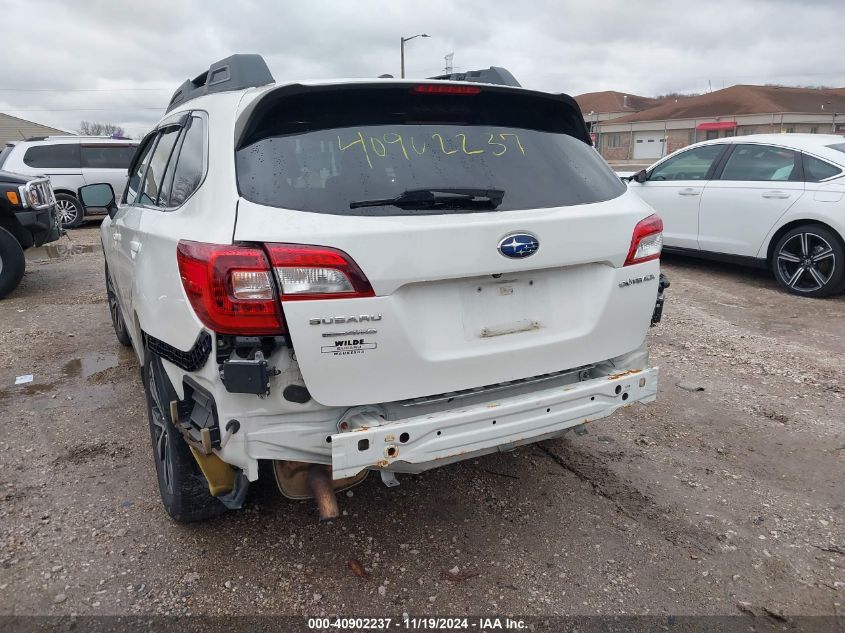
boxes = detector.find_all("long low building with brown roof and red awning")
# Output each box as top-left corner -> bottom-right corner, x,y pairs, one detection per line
584,85 -> 845,161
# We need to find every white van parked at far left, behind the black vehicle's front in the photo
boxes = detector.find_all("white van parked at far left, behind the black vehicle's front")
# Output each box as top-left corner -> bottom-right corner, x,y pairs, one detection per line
0,136 -> 138,228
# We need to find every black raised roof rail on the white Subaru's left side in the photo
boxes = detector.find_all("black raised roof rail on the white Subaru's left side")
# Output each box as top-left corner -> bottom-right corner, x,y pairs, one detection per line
167,54 -> 275,112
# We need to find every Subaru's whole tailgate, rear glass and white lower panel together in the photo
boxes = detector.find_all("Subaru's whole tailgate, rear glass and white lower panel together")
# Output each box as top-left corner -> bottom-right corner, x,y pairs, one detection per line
234,84 -> 659,406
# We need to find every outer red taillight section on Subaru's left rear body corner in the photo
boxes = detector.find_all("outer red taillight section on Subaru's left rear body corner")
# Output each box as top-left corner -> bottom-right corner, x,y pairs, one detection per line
176,240 -> 285,336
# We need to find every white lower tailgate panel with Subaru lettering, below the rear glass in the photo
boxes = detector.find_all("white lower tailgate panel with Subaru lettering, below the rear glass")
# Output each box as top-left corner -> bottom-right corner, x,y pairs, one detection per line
235,194 -> 659,406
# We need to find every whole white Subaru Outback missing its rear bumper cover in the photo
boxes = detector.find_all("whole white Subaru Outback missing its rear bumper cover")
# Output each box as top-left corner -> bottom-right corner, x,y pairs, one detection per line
80,55 -> 663,521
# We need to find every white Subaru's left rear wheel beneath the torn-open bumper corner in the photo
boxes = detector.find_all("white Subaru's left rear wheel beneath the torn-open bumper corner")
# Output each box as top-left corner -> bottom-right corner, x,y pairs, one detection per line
144,350 -> 226,523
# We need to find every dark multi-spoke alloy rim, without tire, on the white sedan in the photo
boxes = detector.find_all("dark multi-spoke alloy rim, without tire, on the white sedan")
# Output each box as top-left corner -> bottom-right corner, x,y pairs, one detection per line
777,232 -> 837,292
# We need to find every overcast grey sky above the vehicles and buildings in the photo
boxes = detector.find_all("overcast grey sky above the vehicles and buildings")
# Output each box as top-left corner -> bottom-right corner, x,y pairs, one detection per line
0,0 -> 845,135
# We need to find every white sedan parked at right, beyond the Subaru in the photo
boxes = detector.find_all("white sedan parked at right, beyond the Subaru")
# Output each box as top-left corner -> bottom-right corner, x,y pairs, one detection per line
630,134 -> 845,297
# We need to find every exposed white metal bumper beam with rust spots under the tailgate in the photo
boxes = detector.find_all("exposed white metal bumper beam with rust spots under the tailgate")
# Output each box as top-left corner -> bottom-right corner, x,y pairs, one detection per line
331,367 -> 658,479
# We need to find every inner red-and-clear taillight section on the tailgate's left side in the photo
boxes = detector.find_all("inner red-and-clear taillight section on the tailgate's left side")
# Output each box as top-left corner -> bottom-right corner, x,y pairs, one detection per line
266,244 -> 375,301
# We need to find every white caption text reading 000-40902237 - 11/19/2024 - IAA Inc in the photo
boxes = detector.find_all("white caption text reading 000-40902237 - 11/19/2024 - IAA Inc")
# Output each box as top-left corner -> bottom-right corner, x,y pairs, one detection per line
308,615 -> 528,633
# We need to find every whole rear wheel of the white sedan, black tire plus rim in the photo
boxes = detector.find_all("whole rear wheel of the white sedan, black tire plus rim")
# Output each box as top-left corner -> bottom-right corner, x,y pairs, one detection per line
771,224 -> 845,297
